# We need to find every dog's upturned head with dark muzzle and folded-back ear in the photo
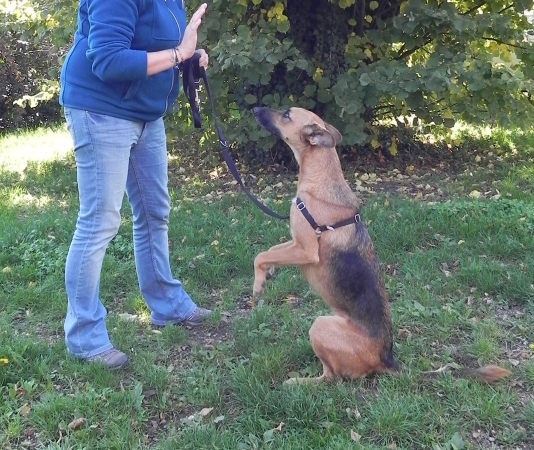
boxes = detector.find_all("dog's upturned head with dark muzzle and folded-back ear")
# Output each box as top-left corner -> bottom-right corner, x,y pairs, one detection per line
254,107 -> 341,159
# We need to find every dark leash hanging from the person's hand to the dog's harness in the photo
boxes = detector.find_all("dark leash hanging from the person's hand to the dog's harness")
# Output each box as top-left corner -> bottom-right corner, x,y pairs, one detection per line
181,53 -> 289,220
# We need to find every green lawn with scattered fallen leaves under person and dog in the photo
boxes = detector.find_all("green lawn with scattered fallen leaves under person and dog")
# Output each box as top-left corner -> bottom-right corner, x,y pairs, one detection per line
0,124 -> 534,450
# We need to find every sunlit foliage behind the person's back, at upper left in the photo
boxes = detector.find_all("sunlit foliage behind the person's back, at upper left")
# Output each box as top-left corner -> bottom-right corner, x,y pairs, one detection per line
0,0 -> 77,132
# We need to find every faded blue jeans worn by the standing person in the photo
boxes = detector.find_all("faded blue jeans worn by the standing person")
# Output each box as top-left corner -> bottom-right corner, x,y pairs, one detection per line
64,108 -> 196,358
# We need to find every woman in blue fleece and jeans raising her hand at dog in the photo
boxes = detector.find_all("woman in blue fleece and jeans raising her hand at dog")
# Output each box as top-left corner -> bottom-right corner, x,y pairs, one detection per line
60,0 -> 211,369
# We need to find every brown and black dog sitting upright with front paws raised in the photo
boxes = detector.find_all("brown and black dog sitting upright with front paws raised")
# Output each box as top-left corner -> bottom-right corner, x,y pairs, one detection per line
253,107 -> 509,383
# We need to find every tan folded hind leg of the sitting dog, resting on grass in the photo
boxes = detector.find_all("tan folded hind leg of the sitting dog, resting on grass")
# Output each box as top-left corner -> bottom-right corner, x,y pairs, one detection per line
288,316 -> 388,384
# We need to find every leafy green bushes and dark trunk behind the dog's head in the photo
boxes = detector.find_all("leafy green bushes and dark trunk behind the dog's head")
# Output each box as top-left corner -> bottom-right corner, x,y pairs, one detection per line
181,0 -> 533,162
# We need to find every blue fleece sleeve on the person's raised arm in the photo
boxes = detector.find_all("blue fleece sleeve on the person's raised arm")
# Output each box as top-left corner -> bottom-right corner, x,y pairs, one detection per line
87,0 -> 147,82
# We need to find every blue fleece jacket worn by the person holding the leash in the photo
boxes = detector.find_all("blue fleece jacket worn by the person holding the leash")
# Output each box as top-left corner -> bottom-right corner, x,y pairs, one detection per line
59,0 -> 186,122
